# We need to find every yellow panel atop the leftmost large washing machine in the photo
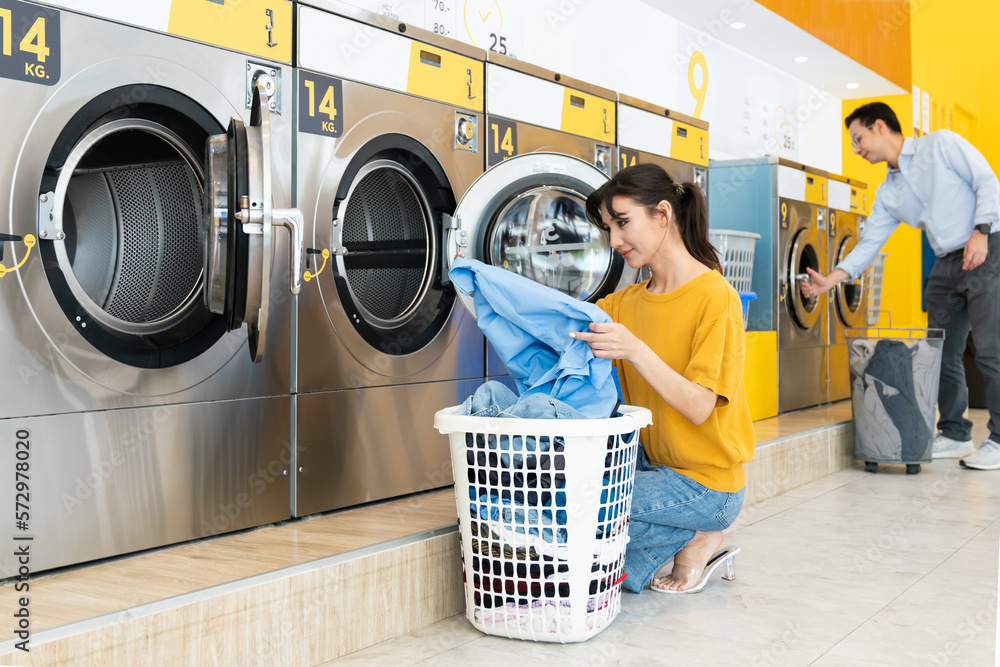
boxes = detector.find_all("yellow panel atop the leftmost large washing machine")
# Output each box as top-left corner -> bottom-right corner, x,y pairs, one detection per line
167,0 -> 292,63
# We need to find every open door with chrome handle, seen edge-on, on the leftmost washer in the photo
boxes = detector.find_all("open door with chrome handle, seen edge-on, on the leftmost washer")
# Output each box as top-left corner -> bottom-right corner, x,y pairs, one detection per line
202,87 -> 302,363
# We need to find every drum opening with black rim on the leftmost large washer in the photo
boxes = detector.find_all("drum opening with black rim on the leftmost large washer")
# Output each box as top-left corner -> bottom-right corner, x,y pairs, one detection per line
39,96 -> 225,368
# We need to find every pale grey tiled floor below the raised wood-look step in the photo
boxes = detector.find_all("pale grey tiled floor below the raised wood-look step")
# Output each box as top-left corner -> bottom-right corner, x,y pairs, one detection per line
328,411 -> 1000,667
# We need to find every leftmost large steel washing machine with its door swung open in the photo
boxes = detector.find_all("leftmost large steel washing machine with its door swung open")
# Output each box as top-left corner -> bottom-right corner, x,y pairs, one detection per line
0,0 -> 298,578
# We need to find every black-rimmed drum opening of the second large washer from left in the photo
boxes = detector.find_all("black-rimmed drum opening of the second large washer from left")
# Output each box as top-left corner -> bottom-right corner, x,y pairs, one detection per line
329,134 -> 455,356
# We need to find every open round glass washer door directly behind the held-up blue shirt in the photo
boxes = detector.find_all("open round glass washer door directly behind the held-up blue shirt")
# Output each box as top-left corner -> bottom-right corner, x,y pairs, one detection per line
445,153 -> 634,313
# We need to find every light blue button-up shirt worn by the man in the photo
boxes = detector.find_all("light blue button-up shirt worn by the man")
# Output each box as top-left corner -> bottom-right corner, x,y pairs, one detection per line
837,130 -> 1000,278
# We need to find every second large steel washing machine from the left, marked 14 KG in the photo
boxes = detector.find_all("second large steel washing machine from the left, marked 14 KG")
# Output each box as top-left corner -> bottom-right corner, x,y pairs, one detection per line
295,0 -> 485,515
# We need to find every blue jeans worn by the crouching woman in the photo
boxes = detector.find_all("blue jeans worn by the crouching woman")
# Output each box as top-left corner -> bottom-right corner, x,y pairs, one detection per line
622,447 -> 744,593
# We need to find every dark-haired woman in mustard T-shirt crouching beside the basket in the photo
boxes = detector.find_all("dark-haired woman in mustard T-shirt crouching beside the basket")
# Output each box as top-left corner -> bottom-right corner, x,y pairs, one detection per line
574,164 -> 754,593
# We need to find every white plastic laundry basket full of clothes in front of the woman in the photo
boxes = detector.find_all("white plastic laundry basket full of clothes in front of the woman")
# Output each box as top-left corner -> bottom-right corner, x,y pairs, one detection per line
434,405 -> 652,642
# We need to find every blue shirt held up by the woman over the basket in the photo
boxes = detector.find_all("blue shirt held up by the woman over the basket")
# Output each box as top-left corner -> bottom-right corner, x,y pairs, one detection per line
448,259 -> 618,419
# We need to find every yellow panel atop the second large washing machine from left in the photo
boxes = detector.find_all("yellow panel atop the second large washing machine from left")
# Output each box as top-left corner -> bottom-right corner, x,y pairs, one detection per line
406,42 -> 485,111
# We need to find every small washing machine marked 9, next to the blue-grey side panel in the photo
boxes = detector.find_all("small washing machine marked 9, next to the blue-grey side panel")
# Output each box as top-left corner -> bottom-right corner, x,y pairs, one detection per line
776,159 -> 829,412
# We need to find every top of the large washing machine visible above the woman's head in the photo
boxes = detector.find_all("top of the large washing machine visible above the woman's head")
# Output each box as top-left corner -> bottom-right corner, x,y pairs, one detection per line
614,95 -> 708,187
